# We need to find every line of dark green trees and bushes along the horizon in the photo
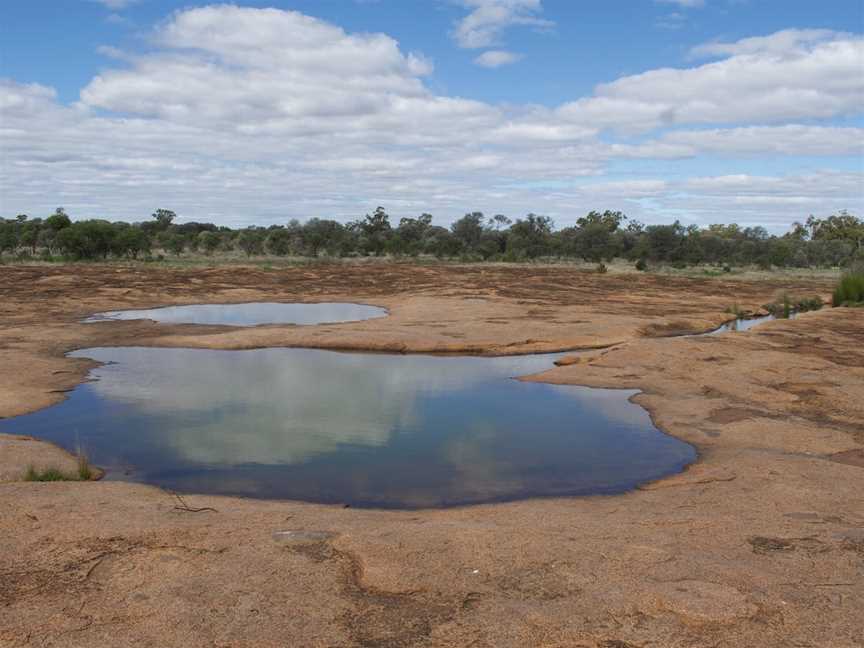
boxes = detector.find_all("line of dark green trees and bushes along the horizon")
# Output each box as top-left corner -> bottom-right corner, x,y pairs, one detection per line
0,207 -> 864,269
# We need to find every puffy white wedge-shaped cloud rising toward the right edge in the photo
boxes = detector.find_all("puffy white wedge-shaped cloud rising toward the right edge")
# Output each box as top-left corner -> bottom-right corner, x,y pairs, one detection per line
560,30 -> 864,131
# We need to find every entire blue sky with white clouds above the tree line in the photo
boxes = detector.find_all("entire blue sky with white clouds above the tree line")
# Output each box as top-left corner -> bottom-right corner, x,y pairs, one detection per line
0,0 -> 864,233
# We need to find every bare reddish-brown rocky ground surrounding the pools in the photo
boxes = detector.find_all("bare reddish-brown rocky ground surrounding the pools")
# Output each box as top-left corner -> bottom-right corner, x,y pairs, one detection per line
0,265 -> 864,648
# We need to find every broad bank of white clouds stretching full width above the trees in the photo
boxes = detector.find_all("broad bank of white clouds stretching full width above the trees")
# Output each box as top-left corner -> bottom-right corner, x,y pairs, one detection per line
0,3 -> 864,226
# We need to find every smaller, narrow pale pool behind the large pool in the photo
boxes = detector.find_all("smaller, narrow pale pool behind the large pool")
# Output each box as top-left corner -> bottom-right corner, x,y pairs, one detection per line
84,302 -> 387,326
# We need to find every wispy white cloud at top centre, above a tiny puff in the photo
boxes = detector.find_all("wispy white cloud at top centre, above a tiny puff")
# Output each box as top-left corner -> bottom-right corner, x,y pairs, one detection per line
453,0 -> 554,49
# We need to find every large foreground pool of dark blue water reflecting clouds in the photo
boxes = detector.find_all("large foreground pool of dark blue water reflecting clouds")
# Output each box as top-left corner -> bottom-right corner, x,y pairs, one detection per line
0,347 -> 695,508
